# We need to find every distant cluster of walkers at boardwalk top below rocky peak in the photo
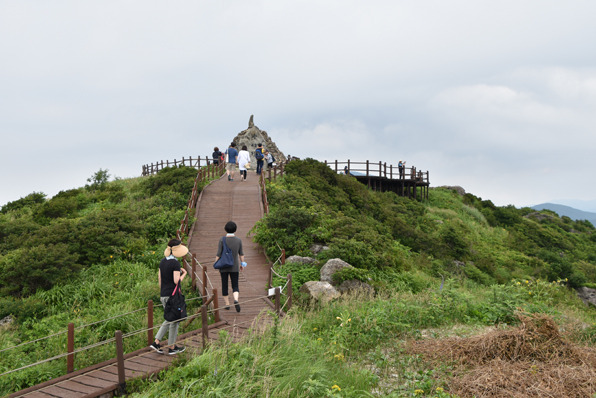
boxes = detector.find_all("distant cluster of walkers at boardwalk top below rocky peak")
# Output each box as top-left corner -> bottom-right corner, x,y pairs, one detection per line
213,142 -> 275,181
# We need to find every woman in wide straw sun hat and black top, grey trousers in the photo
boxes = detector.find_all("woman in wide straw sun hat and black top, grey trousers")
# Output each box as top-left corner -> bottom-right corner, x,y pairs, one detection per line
150,239 -> 188,355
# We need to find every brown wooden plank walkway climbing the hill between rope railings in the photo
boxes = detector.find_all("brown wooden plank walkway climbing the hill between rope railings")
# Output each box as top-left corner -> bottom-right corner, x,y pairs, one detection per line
9,171 -> 270,398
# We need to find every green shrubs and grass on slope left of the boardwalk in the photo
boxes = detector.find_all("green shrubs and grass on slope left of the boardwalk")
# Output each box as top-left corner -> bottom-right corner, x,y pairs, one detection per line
0,167 -> 215,396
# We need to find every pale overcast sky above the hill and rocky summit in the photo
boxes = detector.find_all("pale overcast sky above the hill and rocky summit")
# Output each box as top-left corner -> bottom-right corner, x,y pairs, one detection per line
0,0 -> 596,210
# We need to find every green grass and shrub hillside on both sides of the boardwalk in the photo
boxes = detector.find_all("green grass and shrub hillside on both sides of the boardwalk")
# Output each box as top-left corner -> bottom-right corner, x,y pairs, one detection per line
0,159 -> 596,397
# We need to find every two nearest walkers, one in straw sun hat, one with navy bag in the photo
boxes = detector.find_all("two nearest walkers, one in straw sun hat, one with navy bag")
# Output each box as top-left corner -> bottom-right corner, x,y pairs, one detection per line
149,221 -> 247,355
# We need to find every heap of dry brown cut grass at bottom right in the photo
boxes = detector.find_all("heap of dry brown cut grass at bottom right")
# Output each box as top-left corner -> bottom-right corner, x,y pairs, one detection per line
407,314 -> 596,398
